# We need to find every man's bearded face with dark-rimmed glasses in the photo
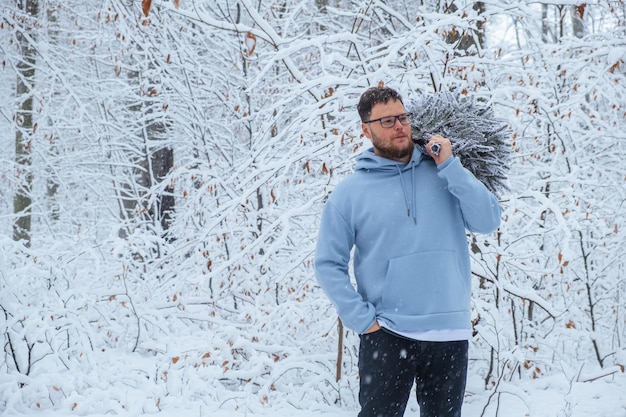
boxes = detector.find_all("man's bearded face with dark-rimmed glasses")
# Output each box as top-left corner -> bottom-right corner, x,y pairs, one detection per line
361,100 -> 413,163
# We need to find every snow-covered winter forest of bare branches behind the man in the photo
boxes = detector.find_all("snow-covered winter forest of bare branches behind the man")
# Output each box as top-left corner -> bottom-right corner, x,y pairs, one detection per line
0,0 -> 626,417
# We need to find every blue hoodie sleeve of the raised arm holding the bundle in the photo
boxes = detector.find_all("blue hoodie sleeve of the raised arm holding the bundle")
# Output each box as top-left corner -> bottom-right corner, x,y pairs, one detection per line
438,157 -> 501,233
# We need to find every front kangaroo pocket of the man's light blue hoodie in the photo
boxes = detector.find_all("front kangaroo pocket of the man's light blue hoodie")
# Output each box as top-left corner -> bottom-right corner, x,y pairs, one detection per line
382,251 -> 470,315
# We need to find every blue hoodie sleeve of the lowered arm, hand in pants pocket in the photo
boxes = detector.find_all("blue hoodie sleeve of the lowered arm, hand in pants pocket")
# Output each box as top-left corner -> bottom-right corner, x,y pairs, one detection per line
315,201 -> 376,334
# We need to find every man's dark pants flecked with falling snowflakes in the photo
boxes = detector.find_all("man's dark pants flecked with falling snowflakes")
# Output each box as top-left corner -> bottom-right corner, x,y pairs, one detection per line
359,329 -> 468,417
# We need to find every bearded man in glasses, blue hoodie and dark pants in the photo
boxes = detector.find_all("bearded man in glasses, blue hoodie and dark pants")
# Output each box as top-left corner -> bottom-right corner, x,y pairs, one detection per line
315,87 -> 500,417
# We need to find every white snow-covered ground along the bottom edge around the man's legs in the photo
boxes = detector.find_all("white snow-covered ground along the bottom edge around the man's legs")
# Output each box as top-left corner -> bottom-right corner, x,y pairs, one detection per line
2,372 -> 626,417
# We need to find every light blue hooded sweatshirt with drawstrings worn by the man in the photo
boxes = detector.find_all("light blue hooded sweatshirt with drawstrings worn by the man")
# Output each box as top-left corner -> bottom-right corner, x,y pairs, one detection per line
315,149 -> 500,334
